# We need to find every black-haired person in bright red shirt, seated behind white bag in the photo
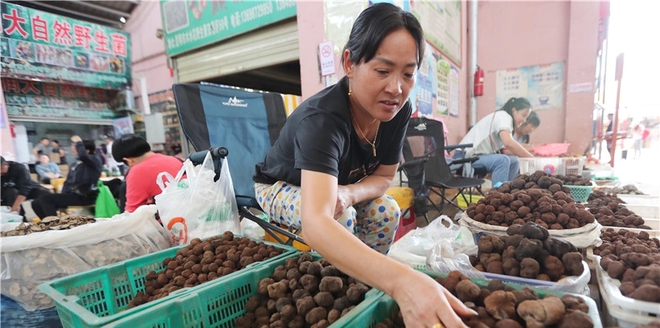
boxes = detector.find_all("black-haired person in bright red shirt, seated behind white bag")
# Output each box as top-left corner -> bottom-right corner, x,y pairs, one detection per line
112,134 -> 182,212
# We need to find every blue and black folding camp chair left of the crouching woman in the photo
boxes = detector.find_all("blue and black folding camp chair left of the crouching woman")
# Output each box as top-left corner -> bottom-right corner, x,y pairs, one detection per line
172,83 -> 304,245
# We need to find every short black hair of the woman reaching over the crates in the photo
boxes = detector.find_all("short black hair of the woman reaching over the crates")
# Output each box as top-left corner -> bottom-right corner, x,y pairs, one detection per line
341,2 -> 426,67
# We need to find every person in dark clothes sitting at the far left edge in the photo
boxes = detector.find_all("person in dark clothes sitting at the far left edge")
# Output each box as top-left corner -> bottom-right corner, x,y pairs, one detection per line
0,157 -> 50,220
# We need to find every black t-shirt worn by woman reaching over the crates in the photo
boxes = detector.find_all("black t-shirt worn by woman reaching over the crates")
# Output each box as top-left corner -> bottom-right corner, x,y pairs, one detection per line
254,78 -> 412,186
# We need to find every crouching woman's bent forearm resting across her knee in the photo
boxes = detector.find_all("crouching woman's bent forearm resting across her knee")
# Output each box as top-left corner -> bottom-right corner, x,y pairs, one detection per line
335,164 -> 399,218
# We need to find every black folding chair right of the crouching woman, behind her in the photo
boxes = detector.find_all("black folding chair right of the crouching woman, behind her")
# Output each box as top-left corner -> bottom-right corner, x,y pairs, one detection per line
401,117 -> 485,220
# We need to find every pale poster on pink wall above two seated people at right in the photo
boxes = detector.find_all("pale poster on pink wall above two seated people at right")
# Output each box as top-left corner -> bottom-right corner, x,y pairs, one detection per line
495,62 -> 564,110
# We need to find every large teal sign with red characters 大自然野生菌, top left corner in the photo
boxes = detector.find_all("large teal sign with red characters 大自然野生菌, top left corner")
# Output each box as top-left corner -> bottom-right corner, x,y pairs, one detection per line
0,1 -> 131,89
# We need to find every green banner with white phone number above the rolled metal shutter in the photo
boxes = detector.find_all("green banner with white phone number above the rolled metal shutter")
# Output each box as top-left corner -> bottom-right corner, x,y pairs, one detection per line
160,0 -> 296,56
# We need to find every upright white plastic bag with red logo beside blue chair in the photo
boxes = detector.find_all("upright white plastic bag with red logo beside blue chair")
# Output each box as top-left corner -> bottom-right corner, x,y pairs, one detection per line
155,153 -> 240,246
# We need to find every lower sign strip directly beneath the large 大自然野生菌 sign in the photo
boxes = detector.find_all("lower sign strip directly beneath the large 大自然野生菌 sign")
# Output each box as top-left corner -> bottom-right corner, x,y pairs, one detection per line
2,78 -> 117,119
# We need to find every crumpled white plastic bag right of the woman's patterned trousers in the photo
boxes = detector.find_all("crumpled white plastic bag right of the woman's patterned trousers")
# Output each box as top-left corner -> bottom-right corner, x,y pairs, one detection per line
388,215 -> 477,272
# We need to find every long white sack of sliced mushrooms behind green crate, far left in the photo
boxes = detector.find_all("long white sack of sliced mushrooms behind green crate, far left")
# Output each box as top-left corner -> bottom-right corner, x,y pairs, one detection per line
0,205 -> 169,311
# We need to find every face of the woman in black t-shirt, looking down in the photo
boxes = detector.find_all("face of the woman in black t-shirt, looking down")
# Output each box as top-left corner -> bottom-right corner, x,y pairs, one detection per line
344,29 -> 417,122
